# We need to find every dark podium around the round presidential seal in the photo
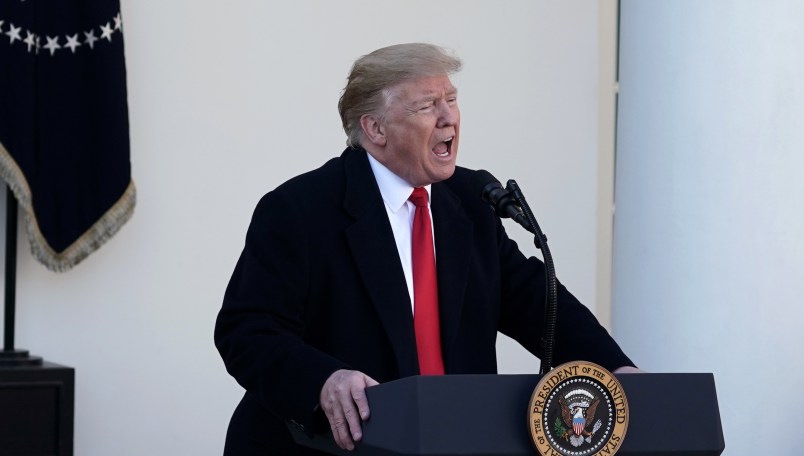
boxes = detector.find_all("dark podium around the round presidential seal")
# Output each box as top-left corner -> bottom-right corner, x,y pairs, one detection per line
290,374 -> 725,456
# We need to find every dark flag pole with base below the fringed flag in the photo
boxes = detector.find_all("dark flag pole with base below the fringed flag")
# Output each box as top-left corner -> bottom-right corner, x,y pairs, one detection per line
0,187 -> 42,366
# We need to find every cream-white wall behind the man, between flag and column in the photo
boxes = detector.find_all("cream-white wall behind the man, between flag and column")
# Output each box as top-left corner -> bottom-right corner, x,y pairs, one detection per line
0,0 -> 616,456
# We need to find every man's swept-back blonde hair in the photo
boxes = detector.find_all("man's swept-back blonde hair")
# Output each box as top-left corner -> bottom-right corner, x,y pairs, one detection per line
338,43 -> 462,146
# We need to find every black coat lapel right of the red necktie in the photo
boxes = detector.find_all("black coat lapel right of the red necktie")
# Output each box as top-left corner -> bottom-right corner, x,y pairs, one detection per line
430,183 -> 473,373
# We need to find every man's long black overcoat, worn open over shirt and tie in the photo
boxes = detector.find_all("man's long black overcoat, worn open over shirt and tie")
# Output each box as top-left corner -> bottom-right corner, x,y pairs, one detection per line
215,148 -> 632,455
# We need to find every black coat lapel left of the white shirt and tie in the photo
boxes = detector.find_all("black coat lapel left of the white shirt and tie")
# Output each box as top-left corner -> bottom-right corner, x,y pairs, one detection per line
343,150 -> 419,377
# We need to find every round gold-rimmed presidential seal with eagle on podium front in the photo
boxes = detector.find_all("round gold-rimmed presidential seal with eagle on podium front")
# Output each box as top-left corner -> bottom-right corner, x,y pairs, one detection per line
528,361 -> 628,456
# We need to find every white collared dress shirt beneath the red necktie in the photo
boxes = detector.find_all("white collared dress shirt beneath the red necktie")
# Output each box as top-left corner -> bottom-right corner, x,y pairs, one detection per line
366,152 -> 435,314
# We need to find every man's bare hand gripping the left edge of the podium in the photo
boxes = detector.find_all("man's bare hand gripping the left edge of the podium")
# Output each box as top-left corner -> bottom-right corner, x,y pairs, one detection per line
319,369 -> 379,451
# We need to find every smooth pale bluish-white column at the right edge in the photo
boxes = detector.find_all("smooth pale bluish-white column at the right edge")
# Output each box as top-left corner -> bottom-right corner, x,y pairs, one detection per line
613,0 -> 804,456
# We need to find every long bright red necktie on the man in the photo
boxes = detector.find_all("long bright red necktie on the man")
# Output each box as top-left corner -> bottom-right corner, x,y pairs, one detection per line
409,187 -> 444,375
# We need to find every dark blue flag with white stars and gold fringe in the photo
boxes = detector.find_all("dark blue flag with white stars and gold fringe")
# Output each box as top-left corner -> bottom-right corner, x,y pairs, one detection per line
0,0 -> 136,271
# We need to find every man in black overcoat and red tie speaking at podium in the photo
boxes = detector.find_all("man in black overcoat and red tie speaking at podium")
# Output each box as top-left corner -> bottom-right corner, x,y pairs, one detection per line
215,44 -> 633,456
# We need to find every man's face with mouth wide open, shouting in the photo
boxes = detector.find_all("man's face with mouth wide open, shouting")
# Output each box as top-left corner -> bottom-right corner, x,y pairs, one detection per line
366,75 -> 461,187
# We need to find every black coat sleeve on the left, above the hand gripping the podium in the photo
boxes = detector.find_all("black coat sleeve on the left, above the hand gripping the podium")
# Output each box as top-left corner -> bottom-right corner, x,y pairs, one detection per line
215,188 -> 348,427
